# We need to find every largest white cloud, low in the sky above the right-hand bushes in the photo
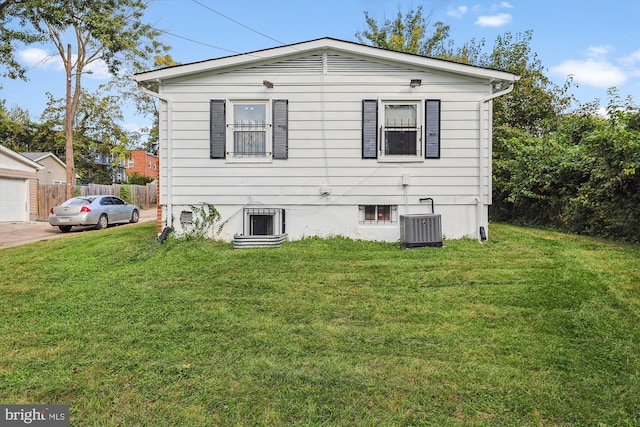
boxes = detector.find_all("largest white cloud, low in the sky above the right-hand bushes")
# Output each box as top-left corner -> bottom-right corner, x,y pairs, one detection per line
550,59 -> 628,89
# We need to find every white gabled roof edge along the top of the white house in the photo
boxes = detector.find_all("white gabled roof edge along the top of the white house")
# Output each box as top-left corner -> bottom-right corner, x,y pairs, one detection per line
132,37 -> 520,90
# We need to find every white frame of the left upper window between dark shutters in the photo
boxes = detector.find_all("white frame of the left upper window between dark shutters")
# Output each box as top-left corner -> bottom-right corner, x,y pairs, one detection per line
226,99 -> 273,163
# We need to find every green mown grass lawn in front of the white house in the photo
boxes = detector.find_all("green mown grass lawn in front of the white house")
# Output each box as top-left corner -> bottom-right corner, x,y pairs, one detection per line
0,224 -> 640,426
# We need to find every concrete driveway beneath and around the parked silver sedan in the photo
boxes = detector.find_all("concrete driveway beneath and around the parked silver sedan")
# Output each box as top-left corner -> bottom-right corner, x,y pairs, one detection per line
0,208 -> 156,249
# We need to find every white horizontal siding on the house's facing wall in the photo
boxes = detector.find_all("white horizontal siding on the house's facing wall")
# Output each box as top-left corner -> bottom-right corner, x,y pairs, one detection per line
154,47 -> 490,238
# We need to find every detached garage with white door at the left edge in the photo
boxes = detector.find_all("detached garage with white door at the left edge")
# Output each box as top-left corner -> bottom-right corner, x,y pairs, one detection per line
0,145 -> 44,222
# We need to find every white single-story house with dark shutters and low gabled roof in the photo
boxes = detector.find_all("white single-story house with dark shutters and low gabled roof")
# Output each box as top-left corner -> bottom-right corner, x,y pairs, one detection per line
133,38 -> 518,246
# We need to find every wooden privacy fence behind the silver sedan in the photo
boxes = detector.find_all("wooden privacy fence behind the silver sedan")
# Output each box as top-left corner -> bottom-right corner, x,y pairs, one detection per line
38,181 -> 157,220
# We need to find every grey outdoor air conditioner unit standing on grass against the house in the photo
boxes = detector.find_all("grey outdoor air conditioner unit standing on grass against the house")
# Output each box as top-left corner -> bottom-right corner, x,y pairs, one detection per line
400,199 -> 442,248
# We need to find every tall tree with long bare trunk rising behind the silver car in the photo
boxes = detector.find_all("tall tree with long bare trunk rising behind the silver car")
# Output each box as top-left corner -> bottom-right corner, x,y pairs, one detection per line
0,0 -> 166,195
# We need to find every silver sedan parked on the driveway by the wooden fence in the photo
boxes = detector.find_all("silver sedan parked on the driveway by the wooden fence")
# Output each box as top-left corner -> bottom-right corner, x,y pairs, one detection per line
49,195 -> 140,233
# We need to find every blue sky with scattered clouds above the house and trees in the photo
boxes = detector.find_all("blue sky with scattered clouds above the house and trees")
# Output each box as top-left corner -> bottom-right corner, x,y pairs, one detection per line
0,0 -> 640,134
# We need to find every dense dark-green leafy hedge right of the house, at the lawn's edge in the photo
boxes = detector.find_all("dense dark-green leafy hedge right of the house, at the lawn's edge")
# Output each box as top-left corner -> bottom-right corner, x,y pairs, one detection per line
491,89 -> 640,242
